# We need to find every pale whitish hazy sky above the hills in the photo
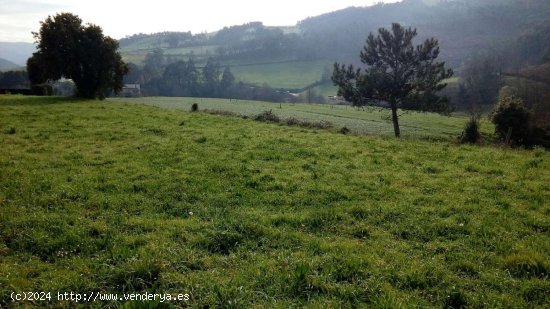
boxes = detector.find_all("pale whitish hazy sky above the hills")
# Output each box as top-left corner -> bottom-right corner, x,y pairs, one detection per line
0,0 -> 398,42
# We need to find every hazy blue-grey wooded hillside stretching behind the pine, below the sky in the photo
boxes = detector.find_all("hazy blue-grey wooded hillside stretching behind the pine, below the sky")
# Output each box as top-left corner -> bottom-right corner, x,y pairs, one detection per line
116,0 -> 550,89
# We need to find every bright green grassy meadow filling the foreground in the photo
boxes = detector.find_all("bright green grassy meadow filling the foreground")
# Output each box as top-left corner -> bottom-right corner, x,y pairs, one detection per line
0,96 -> 550,308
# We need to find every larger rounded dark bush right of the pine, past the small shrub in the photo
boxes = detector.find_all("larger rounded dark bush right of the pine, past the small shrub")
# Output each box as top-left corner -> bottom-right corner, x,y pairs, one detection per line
491,96 -> 531,145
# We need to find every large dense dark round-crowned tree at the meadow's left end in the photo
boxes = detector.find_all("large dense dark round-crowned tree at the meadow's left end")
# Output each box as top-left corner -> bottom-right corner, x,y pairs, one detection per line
27,13 -> 128,99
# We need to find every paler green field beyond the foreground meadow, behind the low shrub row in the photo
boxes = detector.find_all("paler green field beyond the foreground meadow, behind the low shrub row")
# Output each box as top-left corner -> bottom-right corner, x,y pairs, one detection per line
109,97 -> 493,139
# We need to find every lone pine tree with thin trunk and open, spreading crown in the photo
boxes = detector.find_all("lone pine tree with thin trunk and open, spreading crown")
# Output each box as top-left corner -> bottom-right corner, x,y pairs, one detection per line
332,23 -> 453,137
